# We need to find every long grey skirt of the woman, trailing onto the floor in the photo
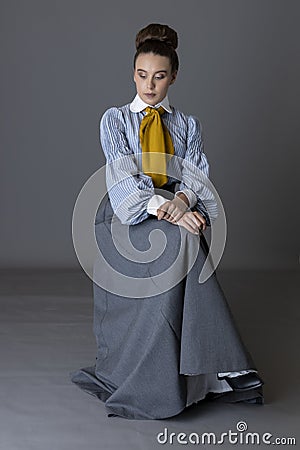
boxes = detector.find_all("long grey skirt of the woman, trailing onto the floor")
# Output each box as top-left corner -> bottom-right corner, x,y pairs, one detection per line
71,189 -> 263,419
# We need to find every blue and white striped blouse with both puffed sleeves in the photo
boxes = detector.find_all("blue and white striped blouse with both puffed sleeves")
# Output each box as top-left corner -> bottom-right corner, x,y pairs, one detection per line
100,104 -> 218,226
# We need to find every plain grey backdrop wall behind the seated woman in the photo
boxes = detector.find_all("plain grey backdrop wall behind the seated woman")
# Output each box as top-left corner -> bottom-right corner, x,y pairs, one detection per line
0,0 -> 300,269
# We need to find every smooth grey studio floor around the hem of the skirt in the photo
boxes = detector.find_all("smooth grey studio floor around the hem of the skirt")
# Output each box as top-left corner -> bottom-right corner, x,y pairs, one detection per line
0,270 -> 300,450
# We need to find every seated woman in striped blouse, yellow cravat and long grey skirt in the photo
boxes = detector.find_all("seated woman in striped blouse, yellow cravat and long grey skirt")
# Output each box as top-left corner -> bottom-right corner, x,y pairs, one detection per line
72,24 -> 263,419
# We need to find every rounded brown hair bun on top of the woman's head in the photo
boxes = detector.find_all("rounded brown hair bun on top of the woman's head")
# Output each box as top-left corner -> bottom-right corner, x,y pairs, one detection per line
135,23 -> 178,50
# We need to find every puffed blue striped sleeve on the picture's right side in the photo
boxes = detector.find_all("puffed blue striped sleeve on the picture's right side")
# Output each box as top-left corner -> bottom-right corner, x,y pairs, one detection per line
179,112 -> 218,226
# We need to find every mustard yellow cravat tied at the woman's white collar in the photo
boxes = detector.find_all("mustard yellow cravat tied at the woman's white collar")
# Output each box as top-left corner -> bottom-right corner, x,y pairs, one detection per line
140,106 -> 174,187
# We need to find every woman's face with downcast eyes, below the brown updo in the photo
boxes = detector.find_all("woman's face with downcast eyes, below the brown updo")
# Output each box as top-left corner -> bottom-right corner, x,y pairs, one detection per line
134,53 -> 177,106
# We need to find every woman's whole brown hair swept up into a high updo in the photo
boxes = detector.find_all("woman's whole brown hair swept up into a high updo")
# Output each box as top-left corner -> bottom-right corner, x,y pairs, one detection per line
134,23 -> 179,73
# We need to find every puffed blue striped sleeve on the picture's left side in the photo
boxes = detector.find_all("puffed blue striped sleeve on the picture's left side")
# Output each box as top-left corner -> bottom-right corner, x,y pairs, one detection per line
100,107 -> 159,225
